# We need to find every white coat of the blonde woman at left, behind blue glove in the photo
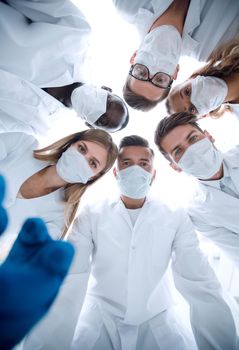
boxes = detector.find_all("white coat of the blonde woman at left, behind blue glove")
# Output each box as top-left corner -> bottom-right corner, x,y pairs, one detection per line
0,132 -> 65,244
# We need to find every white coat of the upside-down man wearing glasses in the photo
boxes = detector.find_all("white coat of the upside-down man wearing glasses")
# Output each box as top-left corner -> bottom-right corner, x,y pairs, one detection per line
113,0 -> 239,61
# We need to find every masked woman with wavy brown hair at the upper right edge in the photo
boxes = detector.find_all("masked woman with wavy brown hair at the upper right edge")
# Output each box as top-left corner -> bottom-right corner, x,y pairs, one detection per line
166,39 -> 239,117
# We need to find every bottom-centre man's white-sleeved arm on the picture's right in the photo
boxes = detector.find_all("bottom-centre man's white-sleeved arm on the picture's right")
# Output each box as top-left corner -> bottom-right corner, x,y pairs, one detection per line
172,211 -> 238,350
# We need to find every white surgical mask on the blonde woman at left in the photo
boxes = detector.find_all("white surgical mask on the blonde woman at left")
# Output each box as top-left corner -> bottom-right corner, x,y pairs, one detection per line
56,146 -> 94,184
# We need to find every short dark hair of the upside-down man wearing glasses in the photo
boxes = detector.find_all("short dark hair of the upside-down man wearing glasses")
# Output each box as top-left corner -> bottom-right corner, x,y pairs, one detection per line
123,77 -> 170,112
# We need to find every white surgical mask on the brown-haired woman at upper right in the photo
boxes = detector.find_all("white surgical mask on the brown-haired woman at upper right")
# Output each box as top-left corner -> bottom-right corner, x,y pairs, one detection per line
191,75 -> 228,115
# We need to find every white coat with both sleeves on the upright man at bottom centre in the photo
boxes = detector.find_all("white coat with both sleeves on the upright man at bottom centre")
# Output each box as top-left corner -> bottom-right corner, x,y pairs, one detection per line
21,198 -> 237,350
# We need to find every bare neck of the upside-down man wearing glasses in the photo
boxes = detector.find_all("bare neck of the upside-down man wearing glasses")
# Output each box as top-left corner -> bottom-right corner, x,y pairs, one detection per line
149,0 -> 190,35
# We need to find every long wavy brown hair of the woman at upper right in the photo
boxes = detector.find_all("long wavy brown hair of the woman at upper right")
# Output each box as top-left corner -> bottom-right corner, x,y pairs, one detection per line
189,37 -> 239,118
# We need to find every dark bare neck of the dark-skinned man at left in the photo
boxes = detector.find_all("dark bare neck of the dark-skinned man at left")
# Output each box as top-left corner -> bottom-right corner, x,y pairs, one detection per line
43,83 -> 83,107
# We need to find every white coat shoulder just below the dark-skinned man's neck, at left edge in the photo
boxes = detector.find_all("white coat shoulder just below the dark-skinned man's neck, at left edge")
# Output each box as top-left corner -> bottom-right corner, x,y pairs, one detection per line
0,69 -> 65,136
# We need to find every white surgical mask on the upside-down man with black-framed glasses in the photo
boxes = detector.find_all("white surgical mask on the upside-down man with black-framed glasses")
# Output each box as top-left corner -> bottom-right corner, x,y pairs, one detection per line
134,25 -> 182,75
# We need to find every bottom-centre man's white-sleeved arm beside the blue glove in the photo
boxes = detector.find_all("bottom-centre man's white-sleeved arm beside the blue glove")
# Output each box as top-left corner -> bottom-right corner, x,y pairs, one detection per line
23,205 -> 93,350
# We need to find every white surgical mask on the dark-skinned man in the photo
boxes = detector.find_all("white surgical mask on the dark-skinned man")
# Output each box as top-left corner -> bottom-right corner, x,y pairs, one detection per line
71,84 -> 108,125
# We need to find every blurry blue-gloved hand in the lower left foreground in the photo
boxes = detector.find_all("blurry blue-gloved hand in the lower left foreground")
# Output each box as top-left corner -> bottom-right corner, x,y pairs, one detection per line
0,177 -> 74,350
